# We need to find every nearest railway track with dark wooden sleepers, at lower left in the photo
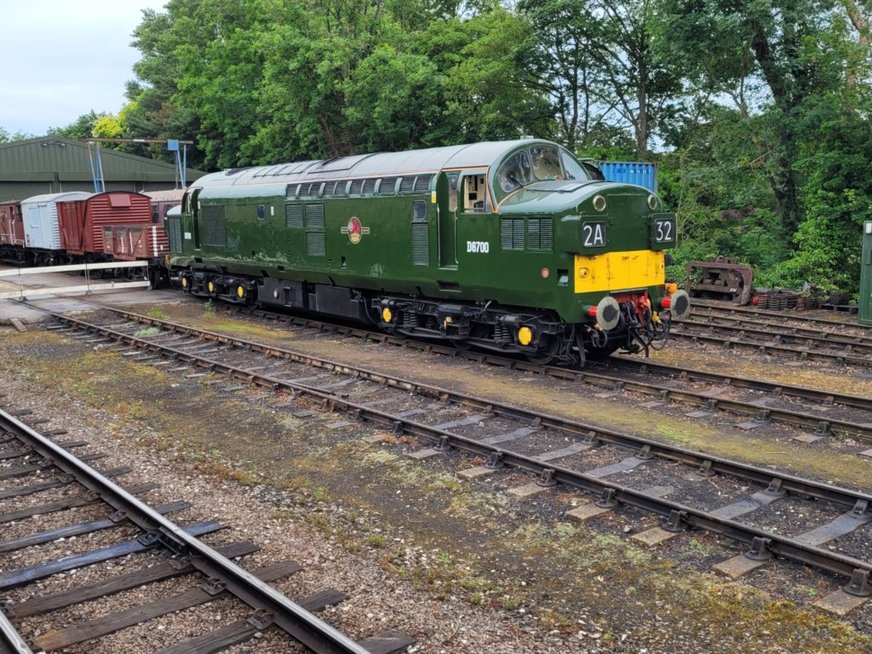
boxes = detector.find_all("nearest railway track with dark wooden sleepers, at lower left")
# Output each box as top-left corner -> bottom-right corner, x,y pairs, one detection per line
0,410 -> 412,654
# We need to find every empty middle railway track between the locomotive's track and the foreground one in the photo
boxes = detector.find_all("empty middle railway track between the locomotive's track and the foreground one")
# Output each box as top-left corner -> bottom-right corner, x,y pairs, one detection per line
30,312 -> 872,607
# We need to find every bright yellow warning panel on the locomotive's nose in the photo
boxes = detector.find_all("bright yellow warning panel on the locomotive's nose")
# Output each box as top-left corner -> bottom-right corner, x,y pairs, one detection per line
575,250 -> 666,293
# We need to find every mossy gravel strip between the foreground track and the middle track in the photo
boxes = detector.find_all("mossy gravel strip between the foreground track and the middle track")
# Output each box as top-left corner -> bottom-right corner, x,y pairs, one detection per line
0,312 -> 870,654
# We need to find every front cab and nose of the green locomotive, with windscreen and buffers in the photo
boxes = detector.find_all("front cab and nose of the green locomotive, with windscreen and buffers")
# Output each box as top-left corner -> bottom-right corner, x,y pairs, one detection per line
493,143 -> 689,357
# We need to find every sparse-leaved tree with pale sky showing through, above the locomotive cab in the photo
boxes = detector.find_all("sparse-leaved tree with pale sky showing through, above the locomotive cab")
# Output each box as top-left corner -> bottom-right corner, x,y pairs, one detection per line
518,0 -> 681,159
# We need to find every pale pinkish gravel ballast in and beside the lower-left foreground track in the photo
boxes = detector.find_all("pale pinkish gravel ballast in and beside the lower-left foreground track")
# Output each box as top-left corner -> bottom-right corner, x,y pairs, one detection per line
0,334 -> 610,654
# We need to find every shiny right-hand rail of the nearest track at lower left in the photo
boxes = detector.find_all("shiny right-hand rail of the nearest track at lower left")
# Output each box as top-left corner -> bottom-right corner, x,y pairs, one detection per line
0,410 -> 368,654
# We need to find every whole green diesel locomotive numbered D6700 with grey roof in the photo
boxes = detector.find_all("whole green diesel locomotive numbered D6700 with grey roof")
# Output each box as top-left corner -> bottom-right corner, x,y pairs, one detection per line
166,139 -> 689,365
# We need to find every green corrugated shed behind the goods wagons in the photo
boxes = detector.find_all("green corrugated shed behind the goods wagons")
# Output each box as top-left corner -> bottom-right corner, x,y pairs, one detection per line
0,136 -> 204,202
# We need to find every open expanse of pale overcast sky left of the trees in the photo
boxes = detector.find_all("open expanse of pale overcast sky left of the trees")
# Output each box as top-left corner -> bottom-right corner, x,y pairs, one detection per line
0,0 -> 167,136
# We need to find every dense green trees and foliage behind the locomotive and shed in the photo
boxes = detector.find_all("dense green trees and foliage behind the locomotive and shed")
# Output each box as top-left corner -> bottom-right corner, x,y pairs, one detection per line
6,0 -> 872,292
